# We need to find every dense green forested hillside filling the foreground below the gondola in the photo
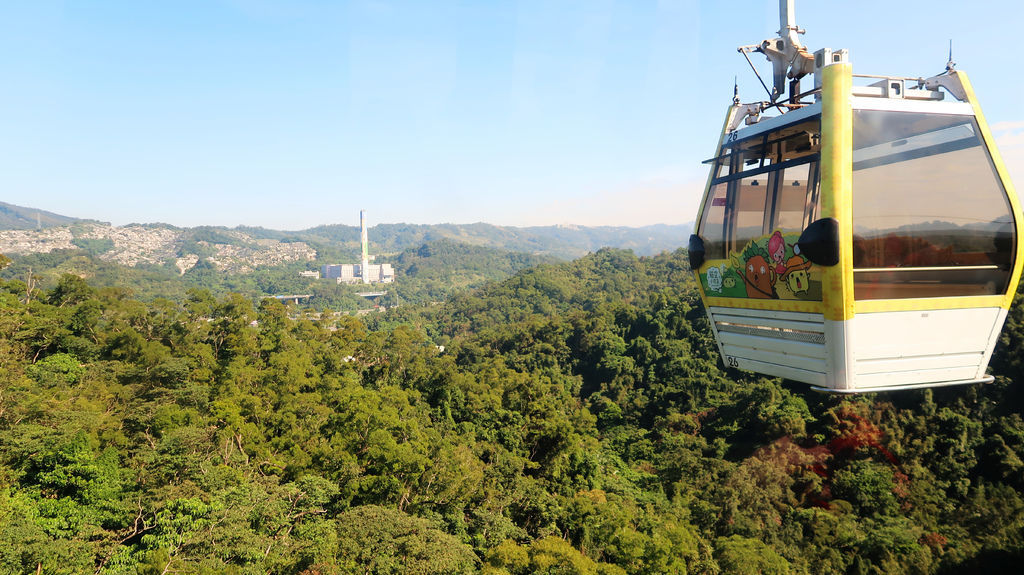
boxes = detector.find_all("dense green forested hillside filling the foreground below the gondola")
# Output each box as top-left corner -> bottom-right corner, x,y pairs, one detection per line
0,250 -> 1024,575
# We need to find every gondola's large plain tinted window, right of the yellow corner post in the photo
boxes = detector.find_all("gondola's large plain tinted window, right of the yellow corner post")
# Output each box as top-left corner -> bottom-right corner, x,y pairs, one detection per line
853,110 -> 1015,300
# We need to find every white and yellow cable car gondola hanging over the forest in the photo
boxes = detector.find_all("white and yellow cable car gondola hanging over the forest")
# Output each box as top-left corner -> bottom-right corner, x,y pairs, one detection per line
689,0 -> 1024,393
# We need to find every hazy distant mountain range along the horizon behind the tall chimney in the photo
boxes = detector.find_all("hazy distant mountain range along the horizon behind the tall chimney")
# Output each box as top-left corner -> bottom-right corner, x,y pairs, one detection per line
0,203 -> 693,257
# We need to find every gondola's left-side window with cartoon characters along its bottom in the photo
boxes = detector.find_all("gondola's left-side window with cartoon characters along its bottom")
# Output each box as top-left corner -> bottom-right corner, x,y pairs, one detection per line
697,117 -> 821,301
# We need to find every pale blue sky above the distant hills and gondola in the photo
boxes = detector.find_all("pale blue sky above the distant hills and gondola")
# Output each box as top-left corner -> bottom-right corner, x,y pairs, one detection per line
0,0 -> 1024,229
